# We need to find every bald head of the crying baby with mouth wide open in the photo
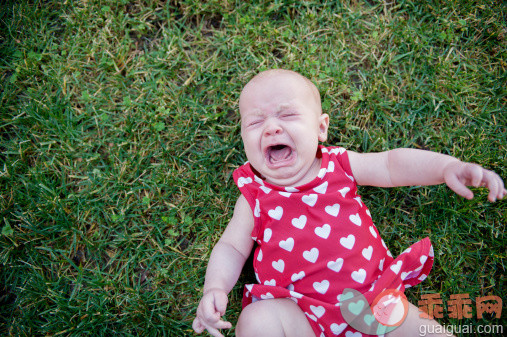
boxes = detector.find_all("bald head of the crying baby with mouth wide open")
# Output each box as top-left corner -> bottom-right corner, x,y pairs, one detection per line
239,72 -> 329,186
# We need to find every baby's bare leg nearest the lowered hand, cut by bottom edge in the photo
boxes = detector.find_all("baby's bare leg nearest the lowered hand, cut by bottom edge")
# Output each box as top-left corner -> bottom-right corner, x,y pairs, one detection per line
236,298 -> 315,337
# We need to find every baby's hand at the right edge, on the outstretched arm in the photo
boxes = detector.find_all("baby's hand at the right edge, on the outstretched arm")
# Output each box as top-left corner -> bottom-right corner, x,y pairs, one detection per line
444,161 -> 507,202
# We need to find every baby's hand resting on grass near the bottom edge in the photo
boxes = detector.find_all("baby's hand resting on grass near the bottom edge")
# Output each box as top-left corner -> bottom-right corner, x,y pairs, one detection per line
192,289 -> 232,337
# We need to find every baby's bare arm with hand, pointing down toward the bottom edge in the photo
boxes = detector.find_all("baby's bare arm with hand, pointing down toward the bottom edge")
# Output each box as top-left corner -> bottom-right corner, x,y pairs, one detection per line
192,195 -> 254,337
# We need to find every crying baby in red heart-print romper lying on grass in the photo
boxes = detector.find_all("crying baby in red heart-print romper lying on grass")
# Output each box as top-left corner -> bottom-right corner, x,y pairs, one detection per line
193,70 -> 507,337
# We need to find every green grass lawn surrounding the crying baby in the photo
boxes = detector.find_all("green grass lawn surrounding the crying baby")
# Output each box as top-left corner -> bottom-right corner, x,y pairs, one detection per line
0,0 -> 507,336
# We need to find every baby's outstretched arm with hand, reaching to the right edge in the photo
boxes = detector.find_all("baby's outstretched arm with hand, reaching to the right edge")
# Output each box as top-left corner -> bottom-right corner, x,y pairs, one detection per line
348,148 -> 507,202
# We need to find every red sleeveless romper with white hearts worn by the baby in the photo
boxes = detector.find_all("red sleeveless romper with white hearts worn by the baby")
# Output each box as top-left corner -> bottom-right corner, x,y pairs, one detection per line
233,146 -> 433,337
